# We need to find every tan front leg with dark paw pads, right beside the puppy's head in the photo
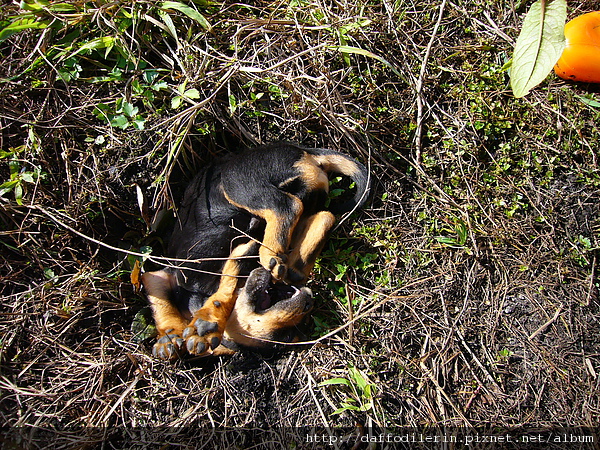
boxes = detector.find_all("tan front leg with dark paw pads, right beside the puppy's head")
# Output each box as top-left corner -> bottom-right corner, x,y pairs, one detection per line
182,242 -> 256,355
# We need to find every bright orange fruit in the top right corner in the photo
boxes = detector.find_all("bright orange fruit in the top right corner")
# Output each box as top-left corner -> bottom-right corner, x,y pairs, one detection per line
554,11 -> 600,83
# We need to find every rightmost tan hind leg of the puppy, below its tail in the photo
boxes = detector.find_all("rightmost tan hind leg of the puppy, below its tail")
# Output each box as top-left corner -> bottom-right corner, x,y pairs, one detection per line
287,211 -> 335,283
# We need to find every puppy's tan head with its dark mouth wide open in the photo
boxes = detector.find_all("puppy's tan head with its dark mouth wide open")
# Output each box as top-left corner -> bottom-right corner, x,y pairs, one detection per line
215,267 -> 313,354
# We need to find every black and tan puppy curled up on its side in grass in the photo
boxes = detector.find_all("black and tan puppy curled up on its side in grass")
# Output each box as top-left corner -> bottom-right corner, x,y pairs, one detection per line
142,143 -> 369,359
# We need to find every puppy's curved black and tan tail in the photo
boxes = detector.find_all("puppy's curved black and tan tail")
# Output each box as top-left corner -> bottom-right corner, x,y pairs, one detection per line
308,148 -> 371,214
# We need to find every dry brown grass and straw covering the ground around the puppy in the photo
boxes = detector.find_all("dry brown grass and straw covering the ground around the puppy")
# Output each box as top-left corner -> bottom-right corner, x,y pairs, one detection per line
0,0 -> 600,448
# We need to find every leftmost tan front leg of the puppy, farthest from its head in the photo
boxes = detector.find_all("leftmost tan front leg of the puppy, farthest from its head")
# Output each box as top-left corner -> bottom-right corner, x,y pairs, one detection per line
142,270 -> 187,359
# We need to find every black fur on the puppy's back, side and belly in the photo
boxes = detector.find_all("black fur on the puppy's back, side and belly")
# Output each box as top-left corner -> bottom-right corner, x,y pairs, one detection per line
168,143 -> 368,302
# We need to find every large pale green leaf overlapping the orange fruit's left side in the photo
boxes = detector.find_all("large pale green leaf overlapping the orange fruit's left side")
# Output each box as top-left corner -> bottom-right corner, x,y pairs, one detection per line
510,0 -> 567,98
